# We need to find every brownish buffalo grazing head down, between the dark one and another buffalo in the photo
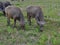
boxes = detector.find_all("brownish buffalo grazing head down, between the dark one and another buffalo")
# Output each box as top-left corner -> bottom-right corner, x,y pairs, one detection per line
5,6 -> 25,29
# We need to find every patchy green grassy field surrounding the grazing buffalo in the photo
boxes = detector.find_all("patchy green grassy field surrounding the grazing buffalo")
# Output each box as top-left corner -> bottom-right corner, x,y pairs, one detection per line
0,0 -> 60,45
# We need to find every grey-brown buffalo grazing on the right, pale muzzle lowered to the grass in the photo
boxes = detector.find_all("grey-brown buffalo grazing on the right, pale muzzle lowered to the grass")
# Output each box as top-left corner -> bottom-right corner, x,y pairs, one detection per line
26,6 -> 45,31
